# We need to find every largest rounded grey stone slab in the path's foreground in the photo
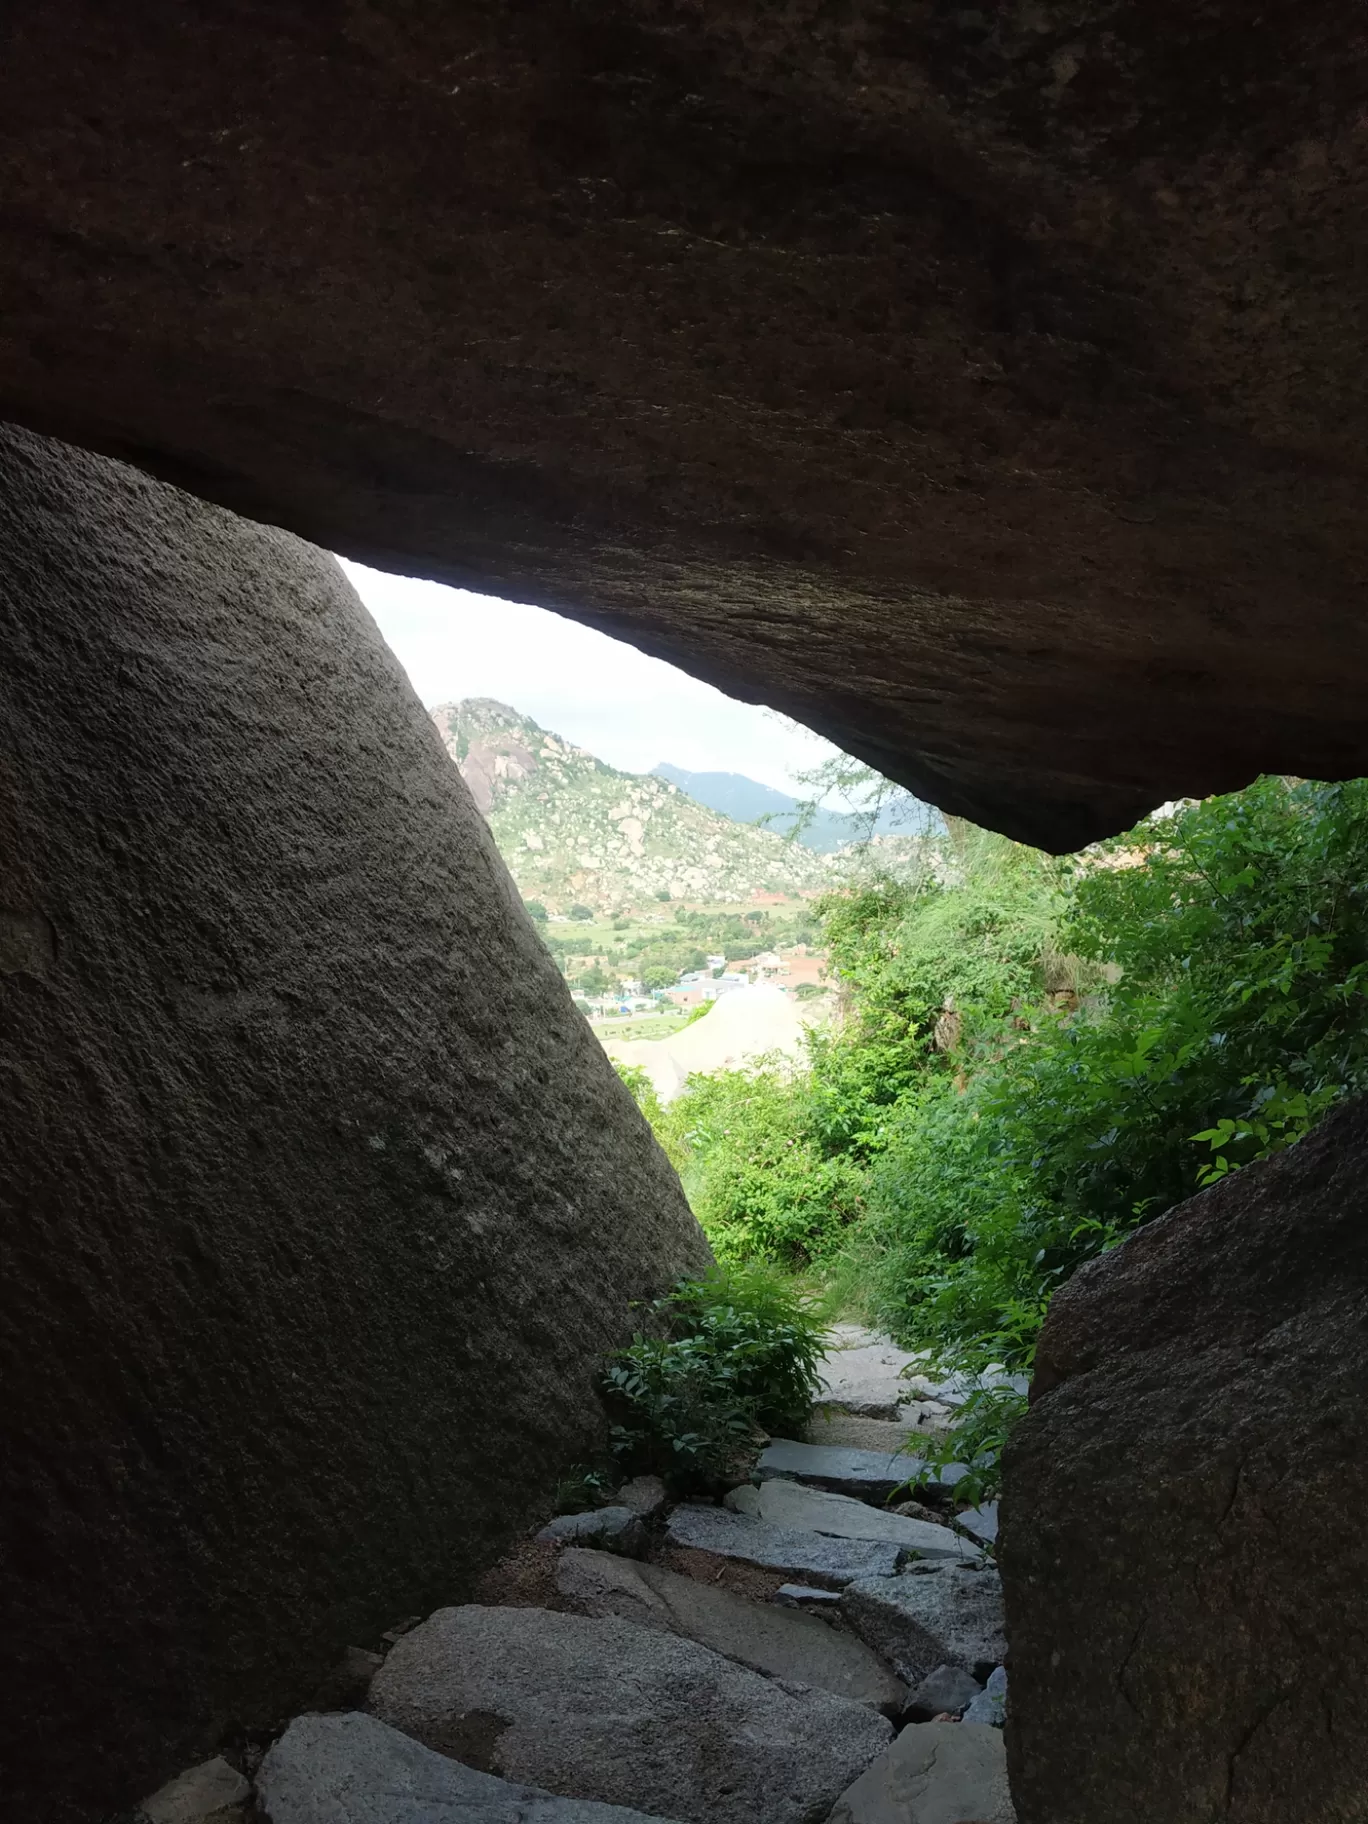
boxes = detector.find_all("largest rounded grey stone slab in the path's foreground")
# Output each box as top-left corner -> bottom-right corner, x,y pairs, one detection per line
370,1607 -> 892,1824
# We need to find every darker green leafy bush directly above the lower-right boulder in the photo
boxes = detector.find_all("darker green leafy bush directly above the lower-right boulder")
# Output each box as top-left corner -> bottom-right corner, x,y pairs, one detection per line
843,779 -> 1368,1366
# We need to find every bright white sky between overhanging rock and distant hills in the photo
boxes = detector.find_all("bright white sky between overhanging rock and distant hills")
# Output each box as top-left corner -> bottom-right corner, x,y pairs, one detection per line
341,558 -> 835,797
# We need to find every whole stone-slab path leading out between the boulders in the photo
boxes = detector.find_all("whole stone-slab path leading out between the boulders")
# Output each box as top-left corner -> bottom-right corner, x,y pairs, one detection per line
142,1326 -> 1012,1824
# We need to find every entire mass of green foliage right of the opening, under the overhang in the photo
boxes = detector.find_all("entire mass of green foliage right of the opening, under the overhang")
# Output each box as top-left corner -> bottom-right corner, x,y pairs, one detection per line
642,779 -> 1368,1378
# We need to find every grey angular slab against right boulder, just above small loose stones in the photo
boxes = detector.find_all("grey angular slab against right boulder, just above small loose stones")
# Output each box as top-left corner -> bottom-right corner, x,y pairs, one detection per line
841,1561 -> 1007,1685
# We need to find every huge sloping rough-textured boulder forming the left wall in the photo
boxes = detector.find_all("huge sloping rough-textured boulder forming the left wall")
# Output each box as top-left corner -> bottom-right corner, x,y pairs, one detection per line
0,419 -> 704,1820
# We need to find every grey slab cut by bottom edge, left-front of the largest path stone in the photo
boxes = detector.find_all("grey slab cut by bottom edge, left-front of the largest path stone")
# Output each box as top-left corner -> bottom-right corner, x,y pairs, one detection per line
257,1711 -> 685,1824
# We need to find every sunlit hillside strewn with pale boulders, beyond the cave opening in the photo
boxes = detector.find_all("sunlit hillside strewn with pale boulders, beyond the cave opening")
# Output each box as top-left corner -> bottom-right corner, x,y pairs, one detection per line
432,697 -> 832,912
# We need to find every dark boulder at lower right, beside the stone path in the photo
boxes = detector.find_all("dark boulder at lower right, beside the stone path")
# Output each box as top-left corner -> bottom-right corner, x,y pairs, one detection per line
1000,1102 -> 1368,1824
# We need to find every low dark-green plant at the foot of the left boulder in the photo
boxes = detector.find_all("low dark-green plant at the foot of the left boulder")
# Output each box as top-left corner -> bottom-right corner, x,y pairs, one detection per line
604,1266 -> 826,1488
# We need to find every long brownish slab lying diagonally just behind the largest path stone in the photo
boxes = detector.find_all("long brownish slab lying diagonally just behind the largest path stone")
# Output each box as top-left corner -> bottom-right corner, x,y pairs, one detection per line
556,1550 -> 907,1716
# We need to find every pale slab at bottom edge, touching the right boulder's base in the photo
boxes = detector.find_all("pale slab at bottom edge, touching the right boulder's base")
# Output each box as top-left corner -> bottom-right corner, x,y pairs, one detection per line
828,1722 -> 1016,1824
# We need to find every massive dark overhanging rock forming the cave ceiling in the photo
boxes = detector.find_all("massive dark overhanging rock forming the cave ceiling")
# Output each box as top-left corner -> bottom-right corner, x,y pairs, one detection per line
0,0 -> 1368,846
